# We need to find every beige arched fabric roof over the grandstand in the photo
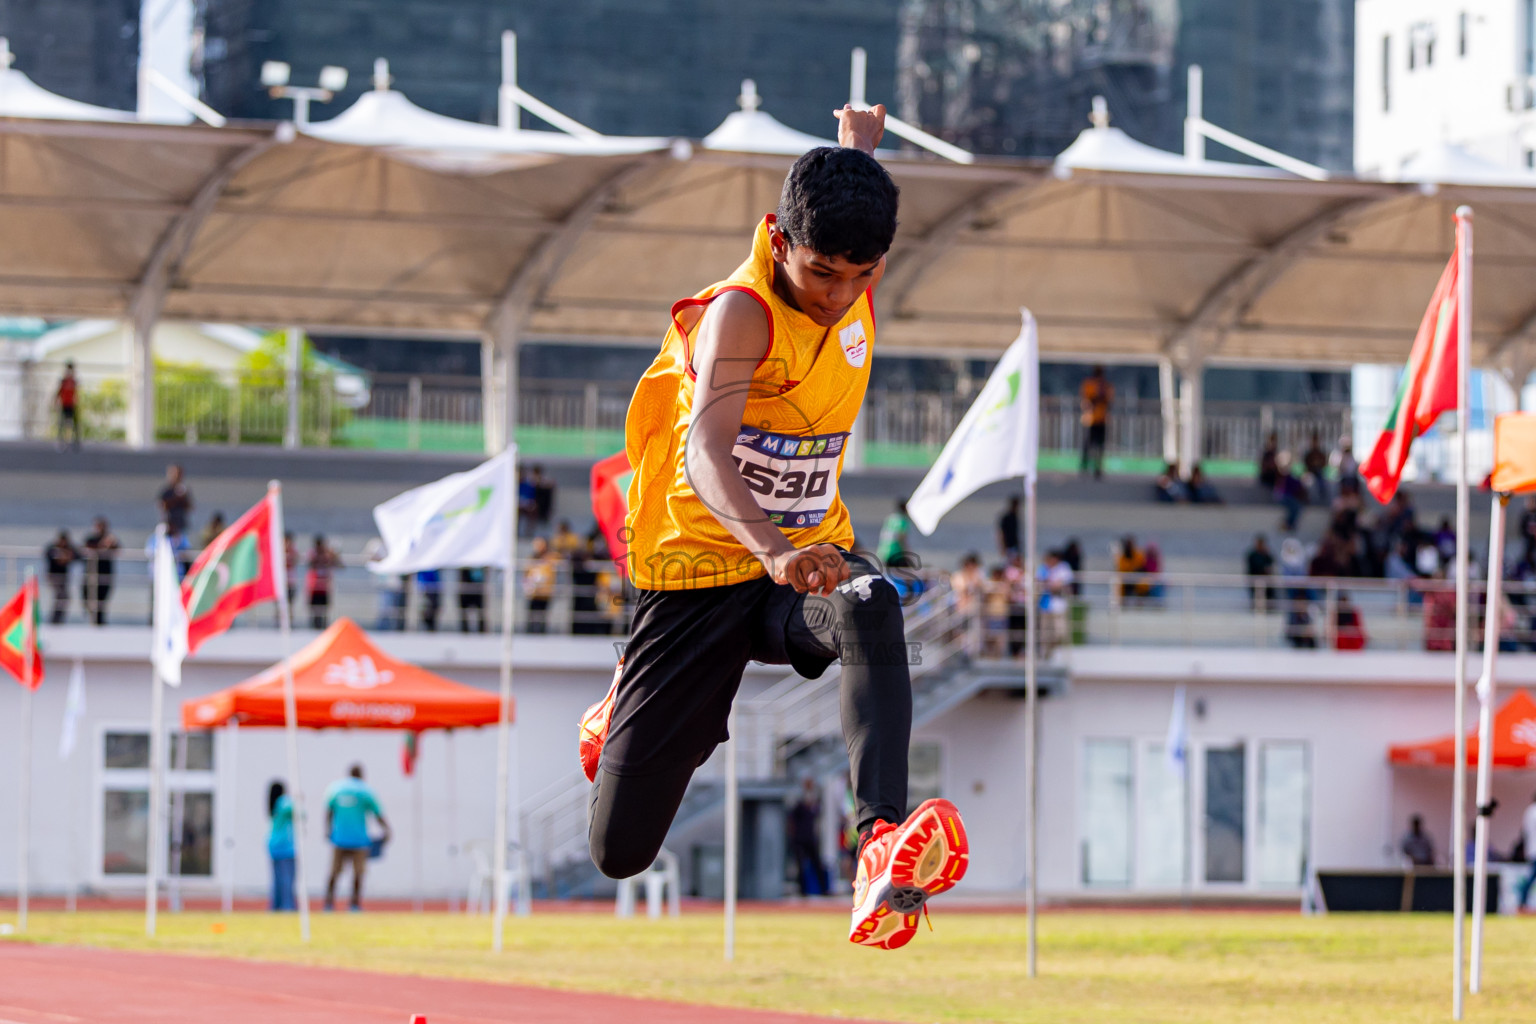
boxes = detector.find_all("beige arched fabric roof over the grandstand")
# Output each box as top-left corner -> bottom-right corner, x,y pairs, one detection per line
0,110 -> 1536,365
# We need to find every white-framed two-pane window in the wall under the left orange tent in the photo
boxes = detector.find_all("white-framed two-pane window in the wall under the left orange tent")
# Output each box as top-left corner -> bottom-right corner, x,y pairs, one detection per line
97,729 -> 215,878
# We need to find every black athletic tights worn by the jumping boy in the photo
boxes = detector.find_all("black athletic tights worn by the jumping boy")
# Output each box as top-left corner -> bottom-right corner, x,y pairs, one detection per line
587,554 -> 912,878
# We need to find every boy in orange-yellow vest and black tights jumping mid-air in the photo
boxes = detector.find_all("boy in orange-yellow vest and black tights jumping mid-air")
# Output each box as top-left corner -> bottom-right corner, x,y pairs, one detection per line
581,107 -> 969,949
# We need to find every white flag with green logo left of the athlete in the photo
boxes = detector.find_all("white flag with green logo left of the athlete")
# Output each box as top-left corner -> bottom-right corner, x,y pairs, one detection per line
369,447 -> 518,576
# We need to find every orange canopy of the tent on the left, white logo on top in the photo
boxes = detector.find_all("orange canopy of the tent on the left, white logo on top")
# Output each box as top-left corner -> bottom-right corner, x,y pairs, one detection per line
181,619 -> 501,732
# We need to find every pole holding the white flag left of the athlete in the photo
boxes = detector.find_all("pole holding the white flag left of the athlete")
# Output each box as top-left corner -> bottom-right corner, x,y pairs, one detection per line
492,316 -> 528,953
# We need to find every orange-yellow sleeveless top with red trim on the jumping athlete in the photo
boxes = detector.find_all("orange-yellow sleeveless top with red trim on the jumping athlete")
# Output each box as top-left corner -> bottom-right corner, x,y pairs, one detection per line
624,215 -> 874,590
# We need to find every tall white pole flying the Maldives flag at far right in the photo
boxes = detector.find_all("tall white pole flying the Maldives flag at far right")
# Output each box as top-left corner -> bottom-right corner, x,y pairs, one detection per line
1452,206 -> 1471,1021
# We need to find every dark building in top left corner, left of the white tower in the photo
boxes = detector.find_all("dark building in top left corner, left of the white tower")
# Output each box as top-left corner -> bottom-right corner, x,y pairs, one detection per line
0,0 -> 140,111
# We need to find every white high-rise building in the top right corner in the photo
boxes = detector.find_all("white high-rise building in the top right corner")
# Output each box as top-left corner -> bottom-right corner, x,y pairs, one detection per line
1355,0 -> 1536,178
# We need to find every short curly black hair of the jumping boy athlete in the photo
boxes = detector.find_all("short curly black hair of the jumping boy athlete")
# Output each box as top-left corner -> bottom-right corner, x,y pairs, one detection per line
779,146 -> 902,264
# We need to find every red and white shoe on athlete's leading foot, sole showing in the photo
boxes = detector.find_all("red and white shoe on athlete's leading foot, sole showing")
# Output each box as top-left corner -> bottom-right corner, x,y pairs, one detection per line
848,800 -> 971,949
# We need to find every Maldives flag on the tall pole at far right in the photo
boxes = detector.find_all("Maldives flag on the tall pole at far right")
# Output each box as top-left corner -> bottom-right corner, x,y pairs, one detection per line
1359,252 -> 1461,505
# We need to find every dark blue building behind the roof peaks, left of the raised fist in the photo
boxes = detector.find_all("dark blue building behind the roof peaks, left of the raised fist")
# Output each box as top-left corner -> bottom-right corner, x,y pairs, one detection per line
200,0 -> 897,138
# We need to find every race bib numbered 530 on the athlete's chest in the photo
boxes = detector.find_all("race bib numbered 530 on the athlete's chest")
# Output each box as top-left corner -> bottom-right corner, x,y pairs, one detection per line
731,427 -> 848,530
